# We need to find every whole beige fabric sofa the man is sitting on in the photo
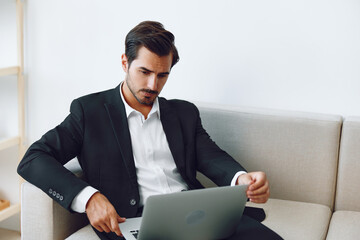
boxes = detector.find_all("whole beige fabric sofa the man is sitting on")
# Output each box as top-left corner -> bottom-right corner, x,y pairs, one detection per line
21,104 -> 360,240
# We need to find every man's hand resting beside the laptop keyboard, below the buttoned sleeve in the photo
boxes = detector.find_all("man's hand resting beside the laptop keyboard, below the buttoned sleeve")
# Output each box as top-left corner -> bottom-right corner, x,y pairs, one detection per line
86,192 -> 125,237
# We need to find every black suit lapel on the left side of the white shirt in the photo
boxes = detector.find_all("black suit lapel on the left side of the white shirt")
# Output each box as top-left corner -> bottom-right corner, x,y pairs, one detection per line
104,85 -> 138,188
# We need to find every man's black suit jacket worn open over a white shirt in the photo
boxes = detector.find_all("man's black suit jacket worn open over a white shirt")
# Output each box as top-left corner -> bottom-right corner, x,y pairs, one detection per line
18,86 -> 244,239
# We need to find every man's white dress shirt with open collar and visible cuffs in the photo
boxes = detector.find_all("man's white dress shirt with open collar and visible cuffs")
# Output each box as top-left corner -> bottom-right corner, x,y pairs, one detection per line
71,84 -> 246,213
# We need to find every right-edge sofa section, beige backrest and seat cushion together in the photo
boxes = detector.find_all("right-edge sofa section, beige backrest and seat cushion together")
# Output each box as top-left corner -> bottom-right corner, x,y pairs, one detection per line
326,117 -> 360,240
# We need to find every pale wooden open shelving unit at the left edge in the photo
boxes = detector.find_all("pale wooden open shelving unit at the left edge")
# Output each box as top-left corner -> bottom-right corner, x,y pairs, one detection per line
0,0 -> 25,239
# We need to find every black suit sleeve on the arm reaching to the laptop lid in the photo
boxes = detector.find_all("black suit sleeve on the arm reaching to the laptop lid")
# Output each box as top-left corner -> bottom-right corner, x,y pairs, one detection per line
195,104 -> 246,186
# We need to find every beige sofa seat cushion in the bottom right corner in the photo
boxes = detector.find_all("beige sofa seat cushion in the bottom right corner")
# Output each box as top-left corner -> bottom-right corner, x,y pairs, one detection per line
326,211 -> 360,240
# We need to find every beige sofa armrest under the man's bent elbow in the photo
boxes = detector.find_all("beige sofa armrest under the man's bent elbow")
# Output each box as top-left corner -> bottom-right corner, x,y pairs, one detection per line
21,182 -> 88,240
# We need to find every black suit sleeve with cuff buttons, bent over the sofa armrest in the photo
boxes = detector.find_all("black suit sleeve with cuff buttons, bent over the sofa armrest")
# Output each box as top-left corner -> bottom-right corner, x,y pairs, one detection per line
17,100 -> 88,211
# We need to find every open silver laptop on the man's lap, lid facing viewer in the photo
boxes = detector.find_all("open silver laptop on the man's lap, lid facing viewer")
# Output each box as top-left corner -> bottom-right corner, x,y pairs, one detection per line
119,185 -> 247,240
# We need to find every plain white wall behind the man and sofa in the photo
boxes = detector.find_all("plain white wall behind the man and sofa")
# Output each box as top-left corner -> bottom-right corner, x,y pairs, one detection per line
25,0 -> 360,142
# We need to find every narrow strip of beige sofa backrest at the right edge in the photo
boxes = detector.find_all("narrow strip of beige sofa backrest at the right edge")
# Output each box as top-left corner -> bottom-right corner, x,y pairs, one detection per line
335,117 -> 360,211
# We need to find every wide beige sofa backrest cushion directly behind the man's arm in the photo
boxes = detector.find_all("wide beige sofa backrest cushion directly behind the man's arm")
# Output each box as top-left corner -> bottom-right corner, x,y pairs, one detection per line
196,103 -> 342,209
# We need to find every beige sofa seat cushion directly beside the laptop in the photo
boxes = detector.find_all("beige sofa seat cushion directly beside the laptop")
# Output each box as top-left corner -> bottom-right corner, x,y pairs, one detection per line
247,199 -> 331,240
